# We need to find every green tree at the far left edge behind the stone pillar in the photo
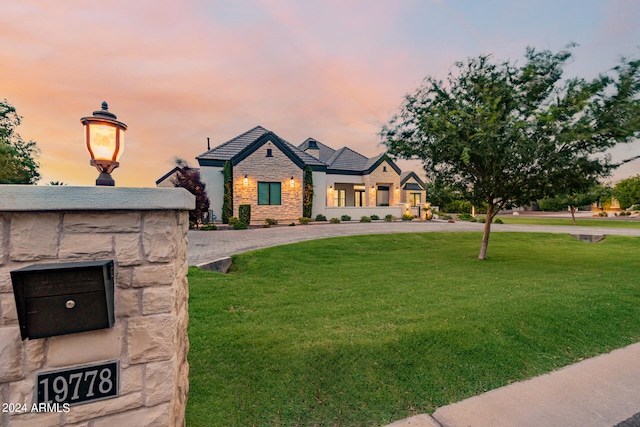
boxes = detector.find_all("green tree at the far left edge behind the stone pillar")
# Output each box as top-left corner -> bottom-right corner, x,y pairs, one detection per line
0,99 -> 40,184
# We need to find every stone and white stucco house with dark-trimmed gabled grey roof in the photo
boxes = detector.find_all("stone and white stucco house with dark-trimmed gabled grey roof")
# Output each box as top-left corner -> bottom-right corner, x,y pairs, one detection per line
196,126 -> 426,221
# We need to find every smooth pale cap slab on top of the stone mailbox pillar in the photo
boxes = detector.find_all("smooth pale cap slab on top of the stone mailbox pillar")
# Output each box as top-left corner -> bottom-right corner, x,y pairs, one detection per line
0,185 -> 196,212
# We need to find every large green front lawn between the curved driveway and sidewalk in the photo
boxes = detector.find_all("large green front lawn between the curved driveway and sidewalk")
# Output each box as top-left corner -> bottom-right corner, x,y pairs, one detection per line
187,233 -> 640,427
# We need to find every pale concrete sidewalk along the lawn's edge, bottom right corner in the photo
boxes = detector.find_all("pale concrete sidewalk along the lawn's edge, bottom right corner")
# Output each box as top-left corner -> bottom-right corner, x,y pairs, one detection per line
389,343 -> 640,427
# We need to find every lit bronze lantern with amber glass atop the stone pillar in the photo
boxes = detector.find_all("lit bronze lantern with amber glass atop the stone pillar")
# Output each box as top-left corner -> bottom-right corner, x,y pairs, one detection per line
80,102 -> 127,186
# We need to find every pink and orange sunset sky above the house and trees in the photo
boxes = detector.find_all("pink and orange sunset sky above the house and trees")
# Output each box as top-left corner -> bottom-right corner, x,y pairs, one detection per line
0,0 -> 640,187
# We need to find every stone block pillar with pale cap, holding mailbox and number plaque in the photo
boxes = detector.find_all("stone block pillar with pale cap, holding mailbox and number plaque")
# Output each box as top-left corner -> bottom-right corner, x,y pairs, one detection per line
0,186 -> 195,427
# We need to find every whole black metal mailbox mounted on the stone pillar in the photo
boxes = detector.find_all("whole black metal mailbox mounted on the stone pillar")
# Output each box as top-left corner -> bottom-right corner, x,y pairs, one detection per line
11,260 -> 115,340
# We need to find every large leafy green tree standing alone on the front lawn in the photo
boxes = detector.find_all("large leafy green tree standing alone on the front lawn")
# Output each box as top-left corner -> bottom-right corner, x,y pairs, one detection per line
381,46 -> 640,259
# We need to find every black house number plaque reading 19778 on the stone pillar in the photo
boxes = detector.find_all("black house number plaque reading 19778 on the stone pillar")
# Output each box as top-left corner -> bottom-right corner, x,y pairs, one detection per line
36,360 -> 120,405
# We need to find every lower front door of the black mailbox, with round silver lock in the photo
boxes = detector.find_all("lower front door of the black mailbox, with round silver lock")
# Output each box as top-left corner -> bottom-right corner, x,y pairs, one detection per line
26,292 -> 113,338
